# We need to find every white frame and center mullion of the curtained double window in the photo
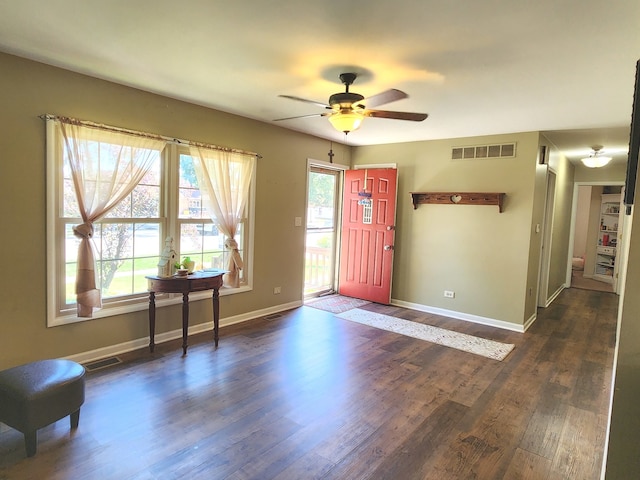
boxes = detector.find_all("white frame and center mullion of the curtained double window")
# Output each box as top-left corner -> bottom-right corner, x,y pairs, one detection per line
46,121 -> 256,327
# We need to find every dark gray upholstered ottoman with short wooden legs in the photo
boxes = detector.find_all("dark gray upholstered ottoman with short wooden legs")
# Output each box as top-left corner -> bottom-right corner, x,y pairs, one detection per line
0,359 -> 85,457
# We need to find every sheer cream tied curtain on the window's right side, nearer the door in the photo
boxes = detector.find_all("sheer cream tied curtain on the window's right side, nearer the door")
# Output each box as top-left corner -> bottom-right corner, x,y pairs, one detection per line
190,145 -> 256,287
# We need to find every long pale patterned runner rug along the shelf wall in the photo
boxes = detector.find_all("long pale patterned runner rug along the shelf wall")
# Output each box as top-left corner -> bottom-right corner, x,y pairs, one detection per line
336,308 -> 515,361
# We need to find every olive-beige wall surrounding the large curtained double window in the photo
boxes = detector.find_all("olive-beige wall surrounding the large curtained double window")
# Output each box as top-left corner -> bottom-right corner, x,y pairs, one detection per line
0,54 -> 350,368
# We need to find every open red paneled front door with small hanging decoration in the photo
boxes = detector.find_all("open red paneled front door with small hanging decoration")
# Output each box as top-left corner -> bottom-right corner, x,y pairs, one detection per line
338,168 -> 397,304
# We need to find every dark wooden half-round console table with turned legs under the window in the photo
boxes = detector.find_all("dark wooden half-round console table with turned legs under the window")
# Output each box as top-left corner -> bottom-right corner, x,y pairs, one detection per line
146,270 -> 225,355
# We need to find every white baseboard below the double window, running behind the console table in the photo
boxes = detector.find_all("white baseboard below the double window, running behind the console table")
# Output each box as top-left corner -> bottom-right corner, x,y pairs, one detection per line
65,300 -> 302,363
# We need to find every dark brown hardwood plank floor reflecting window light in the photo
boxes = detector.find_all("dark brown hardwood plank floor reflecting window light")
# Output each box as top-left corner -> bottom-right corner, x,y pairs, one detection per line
0,289 -> 618,480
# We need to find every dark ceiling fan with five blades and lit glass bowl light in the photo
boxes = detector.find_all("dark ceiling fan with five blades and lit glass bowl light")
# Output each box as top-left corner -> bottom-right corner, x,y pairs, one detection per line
274,73 -> 428,134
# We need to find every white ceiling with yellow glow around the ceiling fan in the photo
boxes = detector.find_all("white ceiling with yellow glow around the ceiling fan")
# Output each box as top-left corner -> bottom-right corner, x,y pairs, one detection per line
0,0 -> 640,167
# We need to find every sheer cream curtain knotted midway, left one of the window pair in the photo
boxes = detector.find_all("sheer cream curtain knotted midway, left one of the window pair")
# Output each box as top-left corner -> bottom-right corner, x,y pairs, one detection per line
56,119 -> 166,317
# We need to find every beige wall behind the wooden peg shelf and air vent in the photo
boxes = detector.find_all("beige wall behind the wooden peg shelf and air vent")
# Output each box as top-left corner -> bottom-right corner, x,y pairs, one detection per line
353,133 -> 538,326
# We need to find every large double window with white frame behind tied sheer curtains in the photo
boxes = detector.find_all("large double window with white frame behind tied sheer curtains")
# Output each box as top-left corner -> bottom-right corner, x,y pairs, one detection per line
47,120 -> 254,326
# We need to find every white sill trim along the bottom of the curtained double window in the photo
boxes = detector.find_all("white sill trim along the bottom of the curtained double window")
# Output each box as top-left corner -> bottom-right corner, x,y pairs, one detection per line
47,285 -> 253,327
